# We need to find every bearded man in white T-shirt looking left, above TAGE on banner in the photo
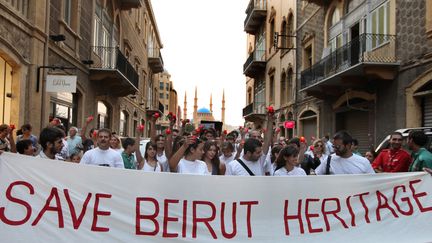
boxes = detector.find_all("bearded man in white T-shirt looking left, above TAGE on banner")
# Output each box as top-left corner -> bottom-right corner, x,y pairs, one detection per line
315,131 -> 375,175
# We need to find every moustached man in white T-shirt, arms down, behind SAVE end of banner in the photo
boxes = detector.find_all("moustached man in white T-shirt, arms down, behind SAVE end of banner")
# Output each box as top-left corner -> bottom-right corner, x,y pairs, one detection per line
80,128 -> 124,168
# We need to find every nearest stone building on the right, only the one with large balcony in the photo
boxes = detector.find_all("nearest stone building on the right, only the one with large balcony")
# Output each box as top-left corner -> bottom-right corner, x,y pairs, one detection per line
297,0 -> 432,152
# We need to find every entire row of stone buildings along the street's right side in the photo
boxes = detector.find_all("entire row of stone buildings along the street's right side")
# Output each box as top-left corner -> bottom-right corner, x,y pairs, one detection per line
243,0 -> 432,152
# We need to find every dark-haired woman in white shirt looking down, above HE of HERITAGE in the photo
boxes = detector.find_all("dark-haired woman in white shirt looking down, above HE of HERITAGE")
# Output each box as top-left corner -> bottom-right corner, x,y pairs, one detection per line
273,145 -> 306,176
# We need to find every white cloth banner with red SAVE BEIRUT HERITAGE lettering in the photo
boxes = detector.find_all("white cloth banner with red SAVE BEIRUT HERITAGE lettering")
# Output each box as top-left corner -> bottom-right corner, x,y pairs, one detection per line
0,153 -> 432,243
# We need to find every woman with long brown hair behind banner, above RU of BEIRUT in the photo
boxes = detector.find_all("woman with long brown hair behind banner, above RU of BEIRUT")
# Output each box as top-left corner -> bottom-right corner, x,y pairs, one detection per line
202,141 -> 226,175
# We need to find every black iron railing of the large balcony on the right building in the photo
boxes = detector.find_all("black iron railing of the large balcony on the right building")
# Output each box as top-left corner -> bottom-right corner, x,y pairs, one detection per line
301,34 -> 397,89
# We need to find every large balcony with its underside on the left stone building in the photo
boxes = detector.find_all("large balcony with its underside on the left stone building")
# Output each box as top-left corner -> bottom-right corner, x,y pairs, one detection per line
90,46 -> 139,97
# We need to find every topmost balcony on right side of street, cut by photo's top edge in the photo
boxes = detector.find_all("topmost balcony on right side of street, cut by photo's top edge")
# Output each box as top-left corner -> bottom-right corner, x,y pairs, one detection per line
244,0 -> 267,35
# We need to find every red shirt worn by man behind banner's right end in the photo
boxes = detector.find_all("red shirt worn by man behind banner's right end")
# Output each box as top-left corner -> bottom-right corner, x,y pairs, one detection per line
372,149 -> 411,173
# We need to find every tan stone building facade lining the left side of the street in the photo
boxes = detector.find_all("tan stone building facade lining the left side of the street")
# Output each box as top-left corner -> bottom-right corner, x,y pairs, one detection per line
0,0 -> 163,136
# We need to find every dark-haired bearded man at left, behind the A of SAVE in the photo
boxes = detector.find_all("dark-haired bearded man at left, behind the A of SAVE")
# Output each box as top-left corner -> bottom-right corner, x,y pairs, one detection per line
38,127 -> 63,160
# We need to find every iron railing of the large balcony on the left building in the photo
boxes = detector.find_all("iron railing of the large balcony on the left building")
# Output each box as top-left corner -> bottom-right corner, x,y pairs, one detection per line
91,46 -> 139,89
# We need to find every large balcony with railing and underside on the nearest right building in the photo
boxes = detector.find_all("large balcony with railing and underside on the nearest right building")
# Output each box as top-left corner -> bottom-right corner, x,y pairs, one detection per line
300,34 -> 399,98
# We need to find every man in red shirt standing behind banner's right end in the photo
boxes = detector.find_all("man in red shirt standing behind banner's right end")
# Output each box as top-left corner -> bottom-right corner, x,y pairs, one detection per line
372,132 -> 411,173
